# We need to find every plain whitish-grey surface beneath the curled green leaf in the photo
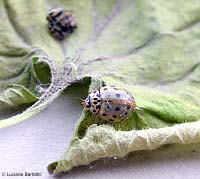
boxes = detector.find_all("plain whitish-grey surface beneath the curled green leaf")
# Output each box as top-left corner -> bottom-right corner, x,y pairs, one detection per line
0,86 -> 200,179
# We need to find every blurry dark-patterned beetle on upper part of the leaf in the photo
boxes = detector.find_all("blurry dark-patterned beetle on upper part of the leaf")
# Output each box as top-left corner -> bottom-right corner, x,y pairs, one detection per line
47,7 -> 77,39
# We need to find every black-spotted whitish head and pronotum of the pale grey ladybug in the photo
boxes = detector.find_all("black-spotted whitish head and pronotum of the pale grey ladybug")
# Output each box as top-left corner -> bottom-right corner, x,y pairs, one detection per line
82,90 -> 101,115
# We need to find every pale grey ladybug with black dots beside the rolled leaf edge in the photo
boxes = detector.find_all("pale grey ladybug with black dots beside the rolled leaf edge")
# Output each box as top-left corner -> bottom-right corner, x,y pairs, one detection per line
82,86 -> 136,122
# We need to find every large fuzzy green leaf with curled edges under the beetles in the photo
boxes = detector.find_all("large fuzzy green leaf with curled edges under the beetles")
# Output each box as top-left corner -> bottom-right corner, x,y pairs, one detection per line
0,0 -> 200,176
